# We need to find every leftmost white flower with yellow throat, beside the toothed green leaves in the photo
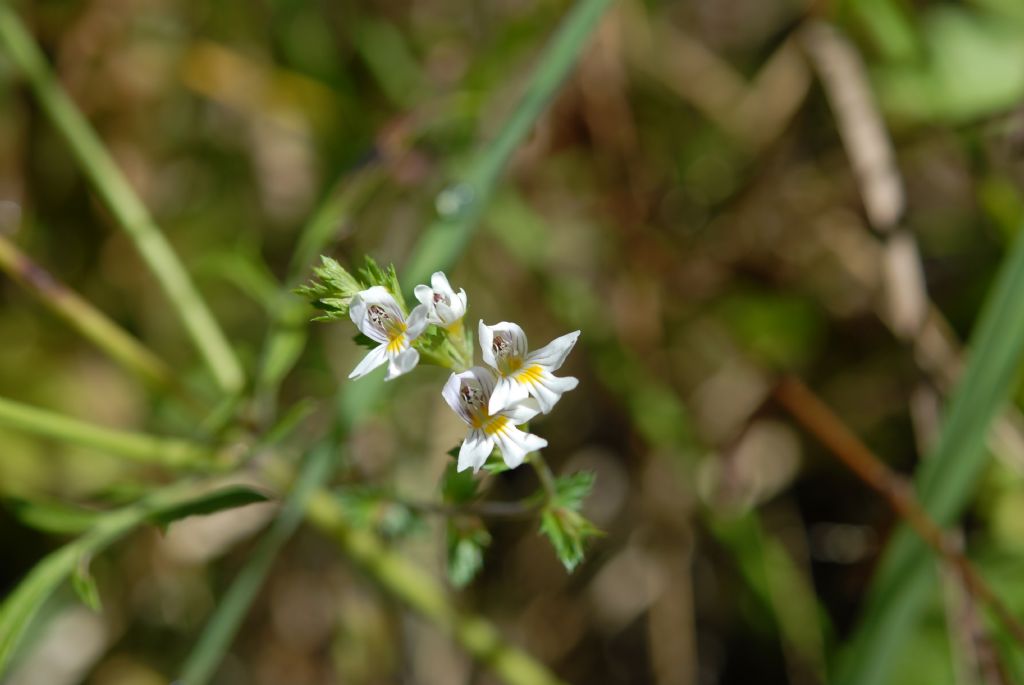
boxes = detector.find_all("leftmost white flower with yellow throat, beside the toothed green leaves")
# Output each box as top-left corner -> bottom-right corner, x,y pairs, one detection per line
348,286 -> 427,381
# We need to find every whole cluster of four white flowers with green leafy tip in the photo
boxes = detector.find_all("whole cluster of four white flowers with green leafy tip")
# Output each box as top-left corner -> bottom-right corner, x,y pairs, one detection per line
301,253 -> 580,472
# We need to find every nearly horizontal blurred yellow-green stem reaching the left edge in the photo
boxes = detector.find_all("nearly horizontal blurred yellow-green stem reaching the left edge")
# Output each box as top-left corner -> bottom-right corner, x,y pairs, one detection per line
0,397 -> 225,471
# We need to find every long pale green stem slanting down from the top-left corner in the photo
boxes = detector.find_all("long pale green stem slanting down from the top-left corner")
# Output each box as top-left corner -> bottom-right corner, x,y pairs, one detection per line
0,2 -> 245,393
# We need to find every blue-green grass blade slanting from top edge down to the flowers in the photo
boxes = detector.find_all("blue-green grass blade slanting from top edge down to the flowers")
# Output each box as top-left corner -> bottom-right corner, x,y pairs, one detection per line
402,0 -> 610,288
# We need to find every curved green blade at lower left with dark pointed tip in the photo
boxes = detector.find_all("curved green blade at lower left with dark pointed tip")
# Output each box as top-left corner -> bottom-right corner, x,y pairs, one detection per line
0,482 -> 264,680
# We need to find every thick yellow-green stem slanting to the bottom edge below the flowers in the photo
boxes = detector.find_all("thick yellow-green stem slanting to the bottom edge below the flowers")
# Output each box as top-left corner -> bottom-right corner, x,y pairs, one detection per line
306,490 -> 561,685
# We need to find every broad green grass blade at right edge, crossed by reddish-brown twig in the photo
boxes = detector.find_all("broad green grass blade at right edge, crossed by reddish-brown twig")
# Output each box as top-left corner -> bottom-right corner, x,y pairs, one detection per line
835,220 -> 1024,685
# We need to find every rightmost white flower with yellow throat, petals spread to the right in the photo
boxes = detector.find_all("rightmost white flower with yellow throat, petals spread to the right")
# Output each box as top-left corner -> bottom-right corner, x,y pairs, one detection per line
479,320 -> 580,414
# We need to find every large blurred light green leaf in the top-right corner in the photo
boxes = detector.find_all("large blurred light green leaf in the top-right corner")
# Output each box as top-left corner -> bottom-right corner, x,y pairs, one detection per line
874,6 -> 1024,122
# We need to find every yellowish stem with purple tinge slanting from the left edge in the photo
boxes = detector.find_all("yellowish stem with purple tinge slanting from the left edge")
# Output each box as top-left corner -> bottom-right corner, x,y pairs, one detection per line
0,236 -> 181,392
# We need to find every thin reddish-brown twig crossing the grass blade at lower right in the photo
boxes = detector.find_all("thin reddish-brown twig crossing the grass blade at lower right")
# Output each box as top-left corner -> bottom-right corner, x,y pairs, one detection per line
772,376 -> 1024,646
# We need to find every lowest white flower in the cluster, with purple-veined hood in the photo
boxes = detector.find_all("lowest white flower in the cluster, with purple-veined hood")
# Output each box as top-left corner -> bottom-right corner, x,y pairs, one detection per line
441,367 -> 548,472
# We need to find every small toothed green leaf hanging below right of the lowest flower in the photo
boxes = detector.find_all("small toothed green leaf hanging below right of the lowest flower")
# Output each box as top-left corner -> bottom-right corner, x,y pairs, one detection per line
541,471 -> 602,572
